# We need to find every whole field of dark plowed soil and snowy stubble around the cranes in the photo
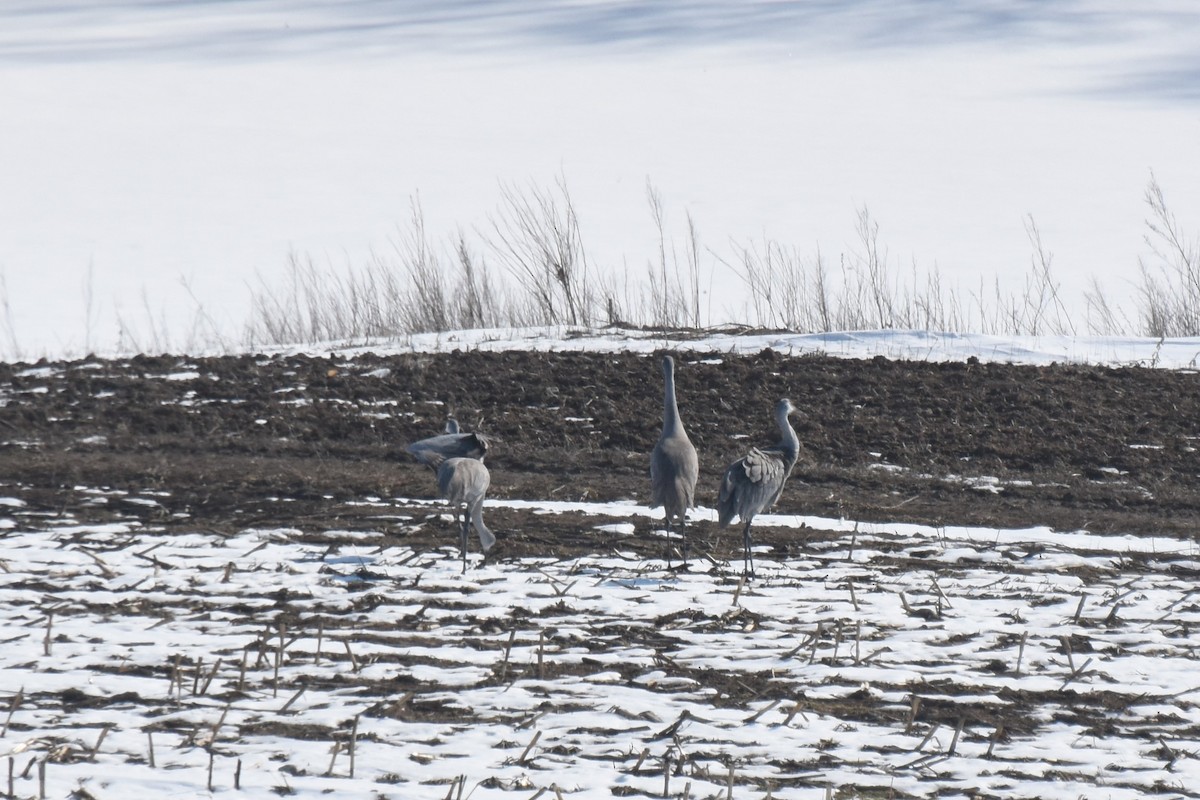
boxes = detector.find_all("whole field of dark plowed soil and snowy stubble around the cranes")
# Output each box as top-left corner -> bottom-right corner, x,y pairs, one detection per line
0,351 -> 1200,798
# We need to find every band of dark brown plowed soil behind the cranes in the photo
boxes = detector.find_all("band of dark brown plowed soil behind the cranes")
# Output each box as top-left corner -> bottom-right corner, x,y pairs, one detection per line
0,350 -> 1200,558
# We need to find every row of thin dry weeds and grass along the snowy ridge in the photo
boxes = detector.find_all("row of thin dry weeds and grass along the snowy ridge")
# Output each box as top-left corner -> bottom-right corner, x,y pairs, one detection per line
245,176 -> 1200,345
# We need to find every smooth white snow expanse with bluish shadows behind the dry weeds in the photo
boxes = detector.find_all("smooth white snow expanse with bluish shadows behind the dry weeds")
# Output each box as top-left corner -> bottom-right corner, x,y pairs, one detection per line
0,0 -> 1200,359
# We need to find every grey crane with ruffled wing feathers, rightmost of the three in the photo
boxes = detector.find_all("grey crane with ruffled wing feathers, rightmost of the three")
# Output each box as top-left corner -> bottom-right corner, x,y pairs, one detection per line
716,398 -> 800,576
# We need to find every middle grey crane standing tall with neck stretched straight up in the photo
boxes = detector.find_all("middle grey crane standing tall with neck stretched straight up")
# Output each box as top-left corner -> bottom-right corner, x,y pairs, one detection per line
650,355 -> 700,566
